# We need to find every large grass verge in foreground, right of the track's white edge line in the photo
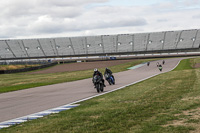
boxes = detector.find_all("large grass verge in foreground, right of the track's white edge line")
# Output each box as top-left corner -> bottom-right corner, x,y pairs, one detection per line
0,57 -> 200,133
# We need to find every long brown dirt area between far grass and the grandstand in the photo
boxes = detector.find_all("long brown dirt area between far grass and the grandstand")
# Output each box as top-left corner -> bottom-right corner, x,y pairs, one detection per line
29,60 -> 133,74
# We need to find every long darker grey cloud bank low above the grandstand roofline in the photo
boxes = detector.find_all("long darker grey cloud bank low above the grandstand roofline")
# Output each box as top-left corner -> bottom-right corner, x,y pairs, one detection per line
30,15 -> 147,33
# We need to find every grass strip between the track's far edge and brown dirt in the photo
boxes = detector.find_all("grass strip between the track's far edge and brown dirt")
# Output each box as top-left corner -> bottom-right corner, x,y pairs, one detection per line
0,59 -> 152,93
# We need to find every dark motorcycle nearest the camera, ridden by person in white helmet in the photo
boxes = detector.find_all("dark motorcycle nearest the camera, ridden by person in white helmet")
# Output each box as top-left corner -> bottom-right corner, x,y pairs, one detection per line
93,75 -> 104,93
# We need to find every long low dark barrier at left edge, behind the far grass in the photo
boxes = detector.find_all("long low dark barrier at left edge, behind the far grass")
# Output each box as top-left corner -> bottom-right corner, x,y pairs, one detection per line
0,62 -> 57,74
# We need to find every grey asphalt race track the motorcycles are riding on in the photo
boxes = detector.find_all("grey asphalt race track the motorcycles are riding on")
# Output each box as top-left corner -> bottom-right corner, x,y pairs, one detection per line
0,58 -> 182,122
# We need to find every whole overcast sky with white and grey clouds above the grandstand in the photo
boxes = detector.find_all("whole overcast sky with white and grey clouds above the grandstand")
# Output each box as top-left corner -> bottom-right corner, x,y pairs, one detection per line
0,0 -> 200,39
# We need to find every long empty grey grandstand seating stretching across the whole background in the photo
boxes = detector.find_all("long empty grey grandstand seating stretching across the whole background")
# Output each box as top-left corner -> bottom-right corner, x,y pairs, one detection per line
0,29 -> 200,60
